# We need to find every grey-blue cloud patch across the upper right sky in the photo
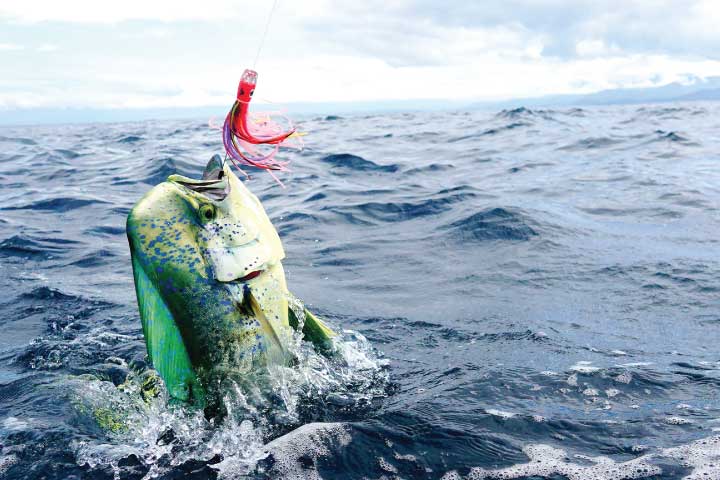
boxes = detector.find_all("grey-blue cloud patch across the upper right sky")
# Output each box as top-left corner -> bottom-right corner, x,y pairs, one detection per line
300,0 -> 720,64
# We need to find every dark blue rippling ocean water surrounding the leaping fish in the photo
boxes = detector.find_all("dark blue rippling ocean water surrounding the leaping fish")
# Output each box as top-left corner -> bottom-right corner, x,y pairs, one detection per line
0,103 -> 720,480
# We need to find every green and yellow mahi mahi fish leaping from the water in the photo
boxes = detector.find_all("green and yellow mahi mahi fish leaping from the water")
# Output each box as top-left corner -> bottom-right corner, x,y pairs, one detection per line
127,155 -> 334,407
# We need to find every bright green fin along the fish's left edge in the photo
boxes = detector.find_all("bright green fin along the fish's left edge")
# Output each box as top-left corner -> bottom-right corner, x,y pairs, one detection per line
131,251 -> 204,405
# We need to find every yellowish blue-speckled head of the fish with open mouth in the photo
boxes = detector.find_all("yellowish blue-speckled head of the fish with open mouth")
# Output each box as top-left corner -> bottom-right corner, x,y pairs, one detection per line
128,155 -> 285,282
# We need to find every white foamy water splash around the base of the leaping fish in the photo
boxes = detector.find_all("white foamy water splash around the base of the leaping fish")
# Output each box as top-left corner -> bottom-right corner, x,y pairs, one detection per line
72,306 -> 388,478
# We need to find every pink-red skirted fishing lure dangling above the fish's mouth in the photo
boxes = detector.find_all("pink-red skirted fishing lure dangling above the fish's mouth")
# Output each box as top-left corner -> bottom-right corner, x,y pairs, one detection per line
223,69 -> 302,176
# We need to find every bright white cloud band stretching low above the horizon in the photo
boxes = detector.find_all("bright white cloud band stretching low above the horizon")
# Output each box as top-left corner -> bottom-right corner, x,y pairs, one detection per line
5,55 -> 720,108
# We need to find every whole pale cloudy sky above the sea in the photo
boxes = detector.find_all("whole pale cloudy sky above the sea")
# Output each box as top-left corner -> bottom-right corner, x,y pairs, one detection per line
0,0 -> 720,109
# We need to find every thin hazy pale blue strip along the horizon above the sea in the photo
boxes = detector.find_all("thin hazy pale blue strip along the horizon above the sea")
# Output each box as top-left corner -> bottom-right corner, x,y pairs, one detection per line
0,77 -> 720,126
